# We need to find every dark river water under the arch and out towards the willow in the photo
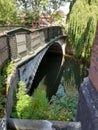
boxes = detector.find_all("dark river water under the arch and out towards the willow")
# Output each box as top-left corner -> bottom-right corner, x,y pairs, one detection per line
30,53 -> 88,99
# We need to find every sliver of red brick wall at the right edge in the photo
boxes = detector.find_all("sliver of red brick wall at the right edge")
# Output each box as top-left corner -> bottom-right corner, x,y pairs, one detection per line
89,24 -> 98,91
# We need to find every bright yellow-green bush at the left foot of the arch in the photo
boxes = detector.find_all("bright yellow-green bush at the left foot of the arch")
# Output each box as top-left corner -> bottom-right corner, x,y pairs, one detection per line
14,82 -> 32,119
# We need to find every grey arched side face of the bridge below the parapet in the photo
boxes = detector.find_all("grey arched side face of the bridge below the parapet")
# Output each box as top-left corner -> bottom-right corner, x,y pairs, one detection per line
18,41 -> 63,92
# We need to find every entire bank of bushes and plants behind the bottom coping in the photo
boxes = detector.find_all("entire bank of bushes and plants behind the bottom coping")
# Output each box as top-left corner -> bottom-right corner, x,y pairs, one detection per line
11,81 -> 77,121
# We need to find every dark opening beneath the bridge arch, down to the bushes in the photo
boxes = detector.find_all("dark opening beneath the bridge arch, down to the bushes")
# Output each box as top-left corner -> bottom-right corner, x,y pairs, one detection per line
29,42 -> 64,99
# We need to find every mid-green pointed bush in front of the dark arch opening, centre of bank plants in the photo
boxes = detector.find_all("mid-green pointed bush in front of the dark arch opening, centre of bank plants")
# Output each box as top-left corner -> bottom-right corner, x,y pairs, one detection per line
32,87 -> 49,119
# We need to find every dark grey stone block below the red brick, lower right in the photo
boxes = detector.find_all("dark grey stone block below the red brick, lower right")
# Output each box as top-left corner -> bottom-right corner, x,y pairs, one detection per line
77,78 -> 98,130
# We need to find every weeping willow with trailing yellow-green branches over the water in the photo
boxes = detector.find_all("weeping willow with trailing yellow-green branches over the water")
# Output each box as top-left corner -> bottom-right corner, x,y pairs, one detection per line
69,0 -> 98,59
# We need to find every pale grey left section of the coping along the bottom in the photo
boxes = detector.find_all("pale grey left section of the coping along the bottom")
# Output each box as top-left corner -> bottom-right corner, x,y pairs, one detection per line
8,118 -> 52,130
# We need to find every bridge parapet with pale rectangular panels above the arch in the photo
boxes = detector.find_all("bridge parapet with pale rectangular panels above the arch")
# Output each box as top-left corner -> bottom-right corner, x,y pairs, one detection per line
0,26 -> 63,64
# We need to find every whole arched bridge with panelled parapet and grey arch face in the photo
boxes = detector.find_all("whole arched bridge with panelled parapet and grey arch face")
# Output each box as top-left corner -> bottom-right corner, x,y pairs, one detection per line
0,26 -> 66,93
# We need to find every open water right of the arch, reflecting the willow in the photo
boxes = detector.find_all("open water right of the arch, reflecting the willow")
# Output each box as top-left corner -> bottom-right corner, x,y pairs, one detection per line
62,57 -> 89,93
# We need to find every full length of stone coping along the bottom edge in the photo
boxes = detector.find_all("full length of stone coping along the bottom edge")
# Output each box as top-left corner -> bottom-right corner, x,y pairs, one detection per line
7,118 -> 81,130
